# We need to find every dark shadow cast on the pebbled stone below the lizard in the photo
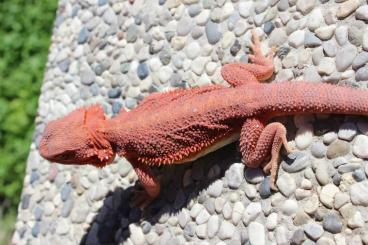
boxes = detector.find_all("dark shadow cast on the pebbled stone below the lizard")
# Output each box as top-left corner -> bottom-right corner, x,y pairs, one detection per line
80,143 -> 241,245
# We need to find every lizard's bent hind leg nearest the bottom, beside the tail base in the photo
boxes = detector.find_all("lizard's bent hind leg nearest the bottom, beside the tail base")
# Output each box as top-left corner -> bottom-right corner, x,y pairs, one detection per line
240,118 -> 291,190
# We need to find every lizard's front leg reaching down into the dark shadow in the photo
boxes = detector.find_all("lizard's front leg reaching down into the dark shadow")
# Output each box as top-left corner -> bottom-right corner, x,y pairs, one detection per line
131,161 -> 160,209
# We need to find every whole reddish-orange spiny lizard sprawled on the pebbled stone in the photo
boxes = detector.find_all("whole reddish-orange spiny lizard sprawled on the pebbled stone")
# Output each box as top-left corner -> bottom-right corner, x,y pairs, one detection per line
40,32 -> 368,207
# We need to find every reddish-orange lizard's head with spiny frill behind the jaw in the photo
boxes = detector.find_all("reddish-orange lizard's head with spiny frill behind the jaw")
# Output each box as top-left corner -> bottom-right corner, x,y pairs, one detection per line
40,106 -> 115,167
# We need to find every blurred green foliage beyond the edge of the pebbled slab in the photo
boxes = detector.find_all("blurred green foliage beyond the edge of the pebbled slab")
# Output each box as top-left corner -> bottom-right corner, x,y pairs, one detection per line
0,0 -> 57,241
